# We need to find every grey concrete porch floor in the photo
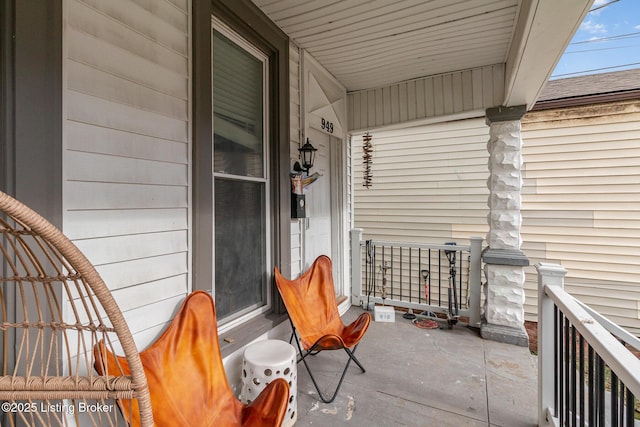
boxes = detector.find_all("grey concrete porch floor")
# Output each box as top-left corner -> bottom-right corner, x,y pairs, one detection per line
295,307 -> 537,427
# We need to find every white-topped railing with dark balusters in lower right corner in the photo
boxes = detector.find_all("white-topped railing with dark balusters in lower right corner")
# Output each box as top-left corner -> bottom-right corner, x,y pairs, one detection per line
536,264 -> 640,426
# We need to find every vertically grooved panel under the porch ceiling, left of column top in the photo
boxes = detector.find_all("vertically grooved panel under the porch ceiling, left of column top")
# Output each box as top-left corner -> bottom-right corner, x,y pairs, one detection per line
348,64 -> 504,131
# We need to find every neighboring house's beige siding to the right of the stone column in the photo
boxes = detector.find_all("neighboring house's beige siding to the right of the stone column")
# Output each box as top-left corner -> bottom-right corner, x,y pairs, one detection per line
522,101 -> 640,334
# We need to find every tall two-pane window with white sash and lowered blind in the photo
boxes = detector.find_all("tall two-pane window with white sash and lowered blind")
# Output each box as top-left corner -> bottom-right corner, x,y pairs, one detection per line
212,19 -> 272,327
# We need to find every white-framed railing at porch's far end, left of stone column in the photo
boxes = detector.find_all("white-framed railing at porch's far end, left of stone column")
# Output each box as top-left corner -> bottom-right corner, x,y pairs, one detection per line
351,229 -> 483,327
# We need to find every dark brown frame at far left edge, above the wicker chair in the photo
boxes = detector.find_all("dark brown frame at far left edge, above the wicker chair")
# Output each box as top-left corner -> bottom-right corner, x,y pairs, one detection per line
0,0 -> 63,425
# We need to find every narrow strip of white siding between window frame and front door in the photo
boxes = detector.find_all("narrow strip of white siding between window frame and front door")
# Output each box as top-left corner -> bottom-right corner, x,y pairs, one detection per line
289,42 -> 303,277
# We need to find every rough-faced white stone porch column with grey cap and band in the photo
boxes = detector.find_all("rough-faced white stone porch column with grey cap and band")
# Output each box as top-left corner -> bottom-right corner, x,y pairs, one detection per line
480,105 -> 529,347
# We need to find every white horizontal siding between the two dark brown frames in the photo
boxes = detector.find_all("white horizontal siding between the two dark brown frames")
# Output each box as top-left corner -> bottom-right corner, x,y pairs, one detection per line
63,0 -> 191,347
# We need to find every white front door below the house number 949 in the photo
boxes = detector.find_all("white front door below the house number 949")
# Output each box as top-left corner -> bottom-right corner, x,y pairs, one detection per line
304,128 -> 342,295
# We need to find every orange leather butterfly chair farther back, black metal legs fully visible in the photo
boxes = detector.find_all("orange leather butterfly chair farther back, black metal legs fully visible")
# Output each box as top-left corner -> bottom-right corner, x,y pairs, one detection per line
275,255 -> 371,403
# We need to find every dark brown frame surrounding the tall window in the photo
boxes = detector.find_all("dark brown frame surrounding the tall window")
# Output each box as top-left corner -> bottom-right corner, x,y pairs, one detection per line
192,0 -> 291,343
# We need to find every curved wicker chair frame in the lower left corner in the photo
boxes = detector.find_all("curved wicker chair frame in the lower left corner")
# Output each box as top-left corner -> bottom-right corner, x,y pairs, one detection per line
0,192 -> 153,427
